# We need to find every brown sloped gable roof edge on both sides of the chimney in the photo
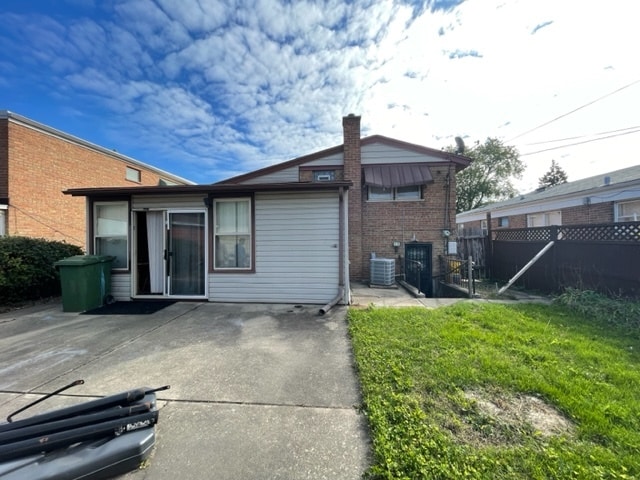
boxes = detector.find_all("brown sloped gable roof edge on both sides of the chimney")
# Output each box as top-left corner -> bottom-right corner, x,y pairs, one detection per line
214,135 -> 472,185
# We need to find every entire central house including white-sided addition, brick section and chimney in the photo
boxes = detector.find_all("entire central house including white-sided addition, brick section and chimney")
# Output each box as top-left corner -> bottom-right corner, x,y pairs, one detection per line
65,115 -> 470,304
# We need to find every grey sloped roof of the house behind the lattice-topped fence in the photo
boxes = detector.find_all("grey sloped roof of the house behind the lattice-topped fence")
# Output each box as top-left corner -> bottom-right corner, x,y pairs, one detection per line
456,165 -> 640,223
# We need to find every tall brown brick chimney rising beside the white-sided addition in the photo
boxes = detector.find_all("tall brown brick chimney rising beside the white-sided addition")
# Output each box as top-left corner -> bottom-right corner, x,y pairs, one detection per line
342,113 -> 363,280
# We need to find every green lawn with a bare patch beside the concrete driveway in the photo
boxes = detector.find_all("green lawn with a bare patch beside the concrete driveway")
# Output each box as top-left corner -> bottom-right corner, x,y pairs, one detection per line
349,302 -> 640,479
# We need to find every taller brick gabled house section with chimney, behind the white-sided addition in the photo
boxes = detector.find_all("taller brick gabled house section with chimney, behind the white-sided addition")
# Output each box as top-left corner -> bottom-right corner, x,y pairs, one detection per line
220,114 -> 470,294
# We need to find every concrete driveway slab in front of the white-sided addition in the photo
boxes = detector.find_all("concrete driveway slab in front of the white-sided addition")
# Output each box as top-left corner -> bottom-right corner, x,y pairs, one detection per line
0,302 -> 369,480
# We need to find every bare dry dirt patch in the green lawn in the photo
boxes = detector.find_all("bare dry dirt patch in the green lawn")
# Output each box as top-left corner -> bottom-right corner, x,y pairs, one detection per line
447,390 -> 575,446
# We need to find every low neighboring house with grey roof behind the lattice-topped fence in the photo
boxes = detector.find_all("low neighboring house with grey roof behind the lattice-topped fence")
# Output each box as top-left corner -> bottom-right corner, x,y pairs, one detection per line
456,165 -> 640,236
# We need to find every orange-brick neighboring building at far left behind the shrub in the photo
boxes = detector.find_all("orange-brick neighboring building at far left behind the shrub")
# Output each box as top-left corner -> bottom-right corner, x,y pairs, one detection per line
0,111 -> 192,246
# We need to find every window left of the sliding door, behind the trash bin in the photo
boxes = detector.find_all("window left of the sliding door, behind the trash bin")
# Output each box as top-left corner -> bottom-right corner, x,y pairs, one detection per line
93,202 -> 129,269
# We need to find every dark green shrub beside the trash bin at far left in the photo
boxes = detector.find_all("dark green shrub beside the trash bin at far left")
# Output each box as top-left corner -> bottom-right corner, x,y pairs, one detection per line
0,237 -> 83,305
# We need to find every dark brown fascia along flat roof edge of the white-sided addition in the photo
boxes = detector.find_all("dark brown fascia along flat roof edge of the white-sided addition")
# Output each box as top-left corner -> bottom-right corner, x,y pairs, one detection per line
62,181 -> 353,198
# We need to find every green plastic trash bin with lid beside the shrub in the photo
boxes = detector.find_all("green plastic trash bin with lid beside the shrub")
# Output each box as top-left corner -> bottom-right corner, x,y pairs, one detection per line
54,255 -> 115,312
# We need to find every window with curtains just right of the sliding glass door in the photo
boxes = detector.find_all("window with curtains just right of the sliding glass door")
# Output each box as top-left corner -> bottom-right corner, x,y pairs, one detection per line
214,198 -> 253,270
